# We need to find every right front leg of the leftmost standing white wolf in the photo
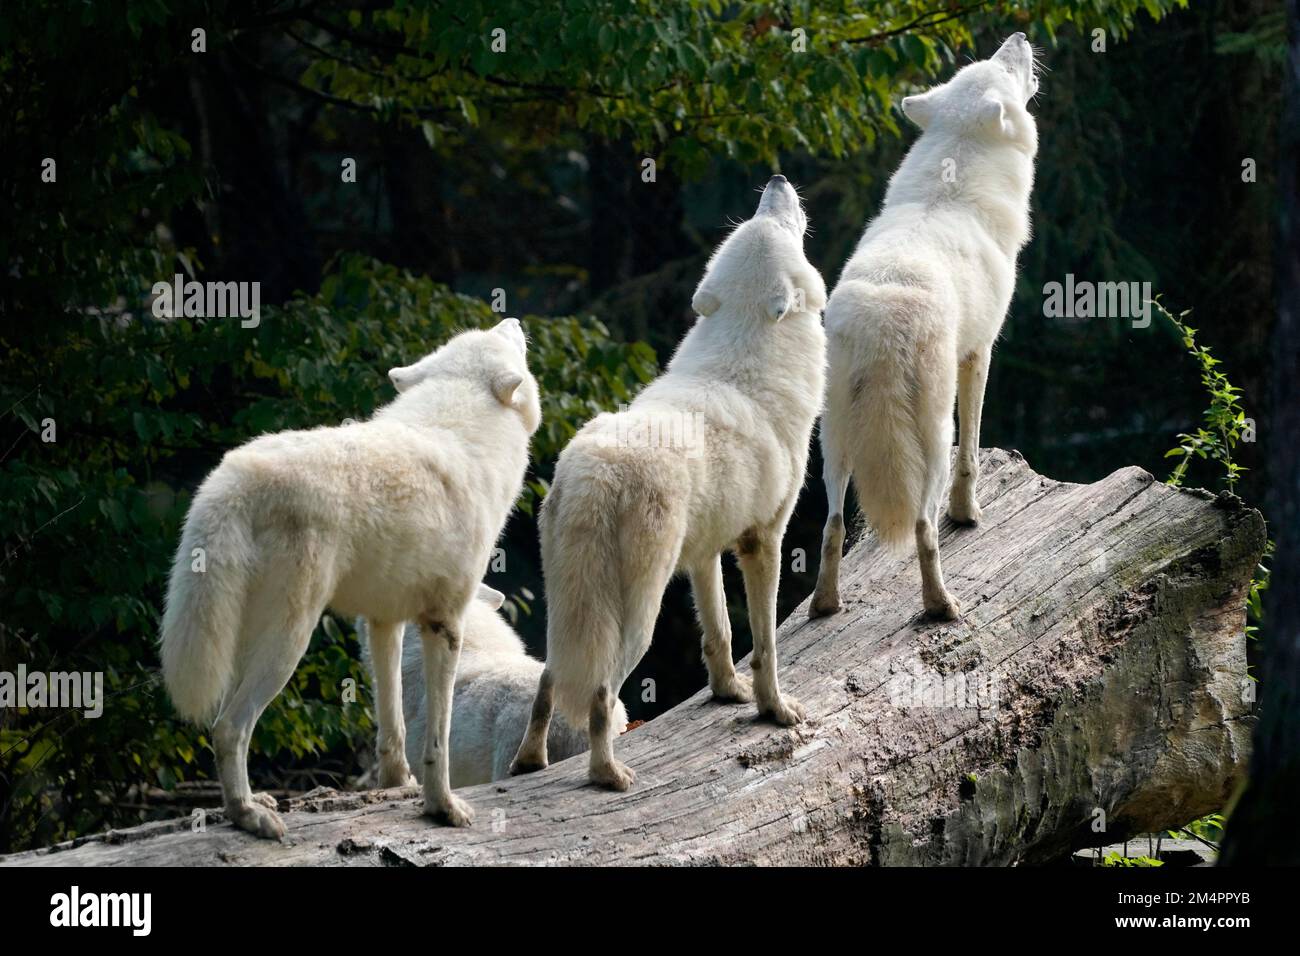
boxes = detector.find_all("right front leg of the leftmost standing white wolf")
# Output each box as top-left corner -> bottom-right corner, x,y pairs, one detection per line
420,618 -> 475,826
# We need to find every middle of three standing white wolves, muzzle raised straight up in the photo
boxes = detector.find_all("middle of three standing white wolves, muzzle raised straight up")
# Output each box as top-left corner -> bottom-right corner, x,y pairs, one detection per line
511,176 -> 826,790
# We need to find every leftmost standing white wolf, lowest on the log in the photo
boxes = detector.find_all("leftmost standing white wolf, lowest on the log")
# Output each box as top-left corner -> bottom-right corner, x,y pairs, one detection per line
163,319 -> 541,839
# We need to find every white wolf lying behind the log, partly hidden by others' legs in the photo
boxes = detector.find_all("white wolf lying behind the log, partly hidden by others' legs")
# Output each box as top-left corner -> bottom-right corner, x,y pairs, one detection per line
356,584 -> 628,790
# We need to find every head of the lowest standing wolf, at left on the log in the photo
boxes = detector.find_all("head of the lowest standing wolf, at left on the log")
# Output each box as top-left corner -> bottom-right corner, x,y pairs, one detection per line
389,319 -> 542,434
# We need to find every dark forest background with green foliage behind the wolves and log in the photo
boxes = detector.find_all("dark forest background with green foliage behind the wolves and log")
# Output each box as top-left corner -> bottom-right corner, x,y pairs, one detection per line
0,0 -> 1294,852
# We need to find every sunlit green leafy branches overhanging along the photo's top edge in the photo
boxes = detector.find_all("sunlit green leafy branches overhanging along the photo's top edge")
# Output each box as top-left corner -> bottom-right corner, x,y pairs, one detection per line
284,0 -> 1186,177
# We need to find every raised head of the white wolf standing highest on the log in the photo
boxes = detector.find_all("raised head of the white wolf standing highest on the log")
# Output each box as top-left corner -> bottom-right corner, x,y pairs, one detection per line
902,34 -> 1039,153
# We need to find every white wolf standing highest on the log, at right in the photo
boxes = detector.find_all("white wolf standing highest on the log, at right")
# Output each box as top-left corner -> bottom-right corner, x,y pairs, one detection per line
811,34 -> 1039,620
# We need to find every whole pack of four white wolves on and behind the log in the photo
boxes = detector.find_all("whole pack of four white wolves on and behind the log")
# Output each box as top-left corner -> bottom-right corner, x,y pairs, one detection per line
160,34 -> 1039,839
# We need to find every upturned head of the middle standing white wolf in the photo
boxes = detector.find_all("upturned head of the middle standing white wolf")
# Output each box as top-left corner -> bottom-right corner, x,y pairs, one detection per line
690,174 -> 826,321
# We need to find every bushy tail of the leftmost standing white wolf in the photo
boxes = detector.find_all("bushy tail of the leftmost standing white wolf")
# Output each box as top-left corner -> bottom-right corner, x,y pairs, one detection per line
161,488 -> 254,724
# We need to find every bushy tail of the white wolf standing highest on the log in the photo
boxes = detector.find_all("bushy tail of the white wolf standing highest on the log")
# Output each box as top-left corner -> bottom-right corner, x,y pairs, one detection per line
822,281 -> 952,551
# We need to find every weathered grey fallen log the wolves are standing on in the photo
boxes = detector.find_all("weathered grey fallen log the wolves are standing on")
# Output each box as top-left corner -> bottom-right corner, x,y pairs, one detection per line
4,450 -> 1265,865
